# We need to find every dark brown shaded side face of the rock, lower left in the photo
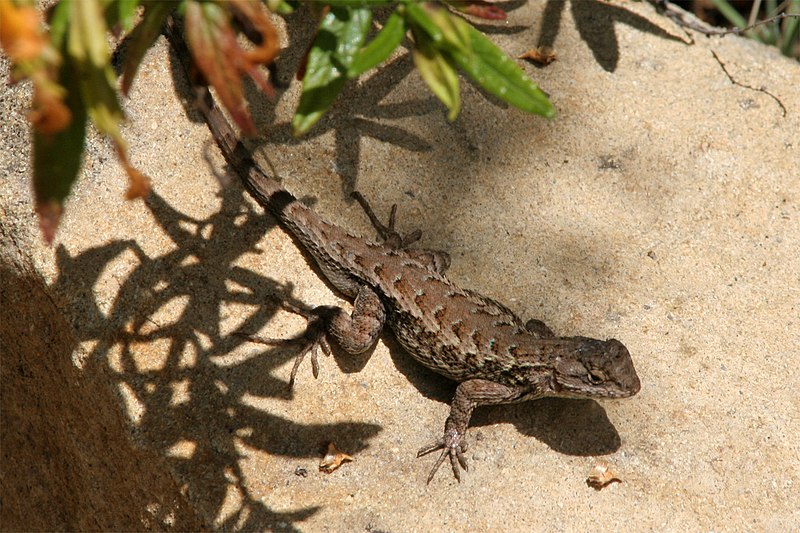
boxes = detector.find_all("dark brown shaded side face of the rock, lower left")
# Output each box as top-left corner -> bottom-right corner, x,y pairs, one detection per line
0,234 -> 208,531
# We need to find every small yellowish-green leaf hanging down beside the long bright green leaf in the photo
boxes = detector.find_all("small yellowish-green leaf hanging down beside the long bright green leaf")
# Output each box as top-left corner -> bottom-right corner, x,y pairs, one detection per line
412,27 -> 461,121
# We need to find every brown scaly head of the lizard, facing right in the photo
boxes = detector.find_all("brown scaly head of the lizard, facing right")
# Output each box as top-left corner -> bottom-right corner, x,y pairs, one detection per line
551,337 -> 641,398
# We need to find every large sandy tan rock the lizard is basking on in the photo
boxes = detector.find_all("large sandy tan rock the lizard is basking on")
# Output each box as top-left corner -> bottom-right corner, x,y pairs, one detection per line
0,0 -> 800,531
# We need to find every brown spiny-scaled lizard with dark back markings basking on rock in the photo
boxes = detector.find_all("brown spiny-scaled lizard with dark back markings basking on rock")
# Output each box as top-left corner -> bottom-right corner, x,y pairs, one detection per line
178,47 -> 641,483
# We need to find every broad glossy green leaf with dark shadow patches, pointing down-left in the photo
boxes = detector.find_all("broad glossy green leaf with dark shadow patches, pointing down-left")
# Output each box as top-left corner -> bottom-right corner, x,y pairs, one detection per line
292,7 -> 372,135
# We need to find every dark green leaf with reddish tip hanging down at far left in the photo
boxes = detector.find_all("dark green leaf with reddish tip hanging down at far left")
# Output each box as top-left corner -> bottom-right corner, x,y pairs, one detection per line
33,56 -> 87,243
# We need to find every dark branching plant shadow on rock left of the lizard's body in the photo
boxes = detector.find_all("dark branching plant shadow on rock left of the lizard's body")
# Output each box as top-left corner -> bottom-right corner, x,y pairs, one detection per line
52,186 -> 380,530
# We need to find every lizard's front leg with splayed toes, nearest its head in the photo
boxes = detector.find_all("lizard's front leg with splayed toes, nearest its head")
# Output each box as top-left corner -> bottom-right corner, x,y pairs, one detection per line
417,379 -> 523,483
